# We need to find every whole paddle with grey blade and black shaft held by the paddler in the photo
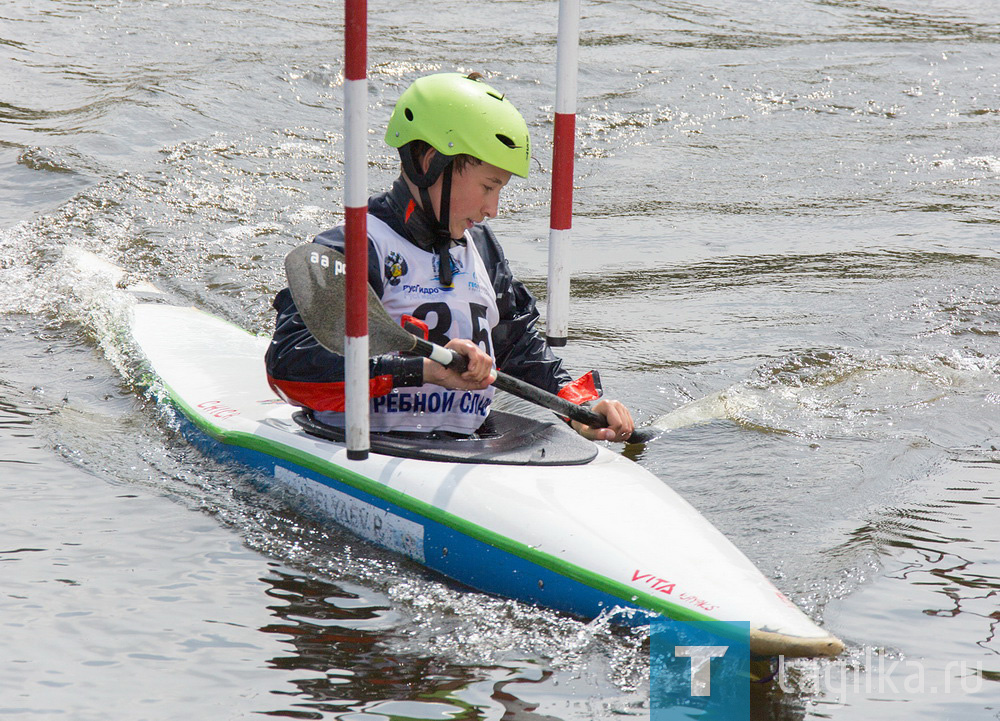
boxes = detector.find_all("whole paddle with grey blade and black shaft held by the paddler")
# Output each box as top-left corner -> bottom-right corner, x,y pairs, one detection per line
285,243 -> 656,443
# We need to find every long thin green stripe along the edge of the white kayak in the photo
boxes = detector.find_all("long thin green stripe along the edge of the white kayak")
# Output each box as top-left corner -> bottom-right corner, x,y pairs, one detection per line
159,380 -> 749,640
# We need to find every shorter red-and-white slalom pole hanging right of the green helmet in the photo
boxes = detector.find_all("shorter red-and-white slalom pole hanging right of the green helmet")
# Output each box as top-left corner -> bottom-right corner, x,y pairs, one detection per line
545,0 -> 580,346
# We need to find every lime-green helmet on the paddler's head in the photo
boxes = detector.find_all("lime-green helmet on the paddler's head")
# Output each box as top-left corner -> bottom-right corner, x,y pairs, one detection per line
385,73 -> 531,178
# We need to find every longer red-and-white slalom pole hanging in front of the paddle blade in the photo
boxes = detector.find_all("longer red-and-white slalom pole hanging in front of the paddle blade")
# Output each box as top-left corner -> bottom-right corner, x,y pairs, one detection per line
344,0 -> 369,461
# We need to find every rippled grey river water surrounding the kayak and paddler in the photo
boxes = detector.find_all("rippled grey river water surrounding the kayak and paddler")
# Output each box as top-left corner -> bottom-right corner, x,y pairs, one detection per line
0,0 -> 1000,721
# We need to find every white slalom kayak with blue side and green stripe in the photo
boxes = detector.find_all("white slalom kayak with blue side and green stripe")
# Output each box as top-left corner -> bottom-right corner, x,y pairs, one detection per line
73,251 -> 843,657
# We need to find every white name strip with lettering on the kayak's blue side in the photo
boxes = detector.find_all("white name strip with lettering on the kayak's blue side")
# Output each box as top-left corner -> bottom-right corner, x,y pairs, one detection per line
274,465 -> 424,563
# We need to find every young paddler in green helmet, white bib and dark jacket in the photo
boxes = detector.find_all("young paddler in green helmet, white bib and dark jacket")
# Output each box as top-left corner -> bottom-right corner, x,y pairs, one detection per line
266,73 -> 634,441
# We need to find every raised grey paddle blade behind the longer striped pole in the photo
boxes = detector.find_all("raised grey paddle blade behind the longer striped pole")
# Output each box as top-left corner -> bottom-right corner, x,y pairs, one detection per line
285,243 -> 416,355
